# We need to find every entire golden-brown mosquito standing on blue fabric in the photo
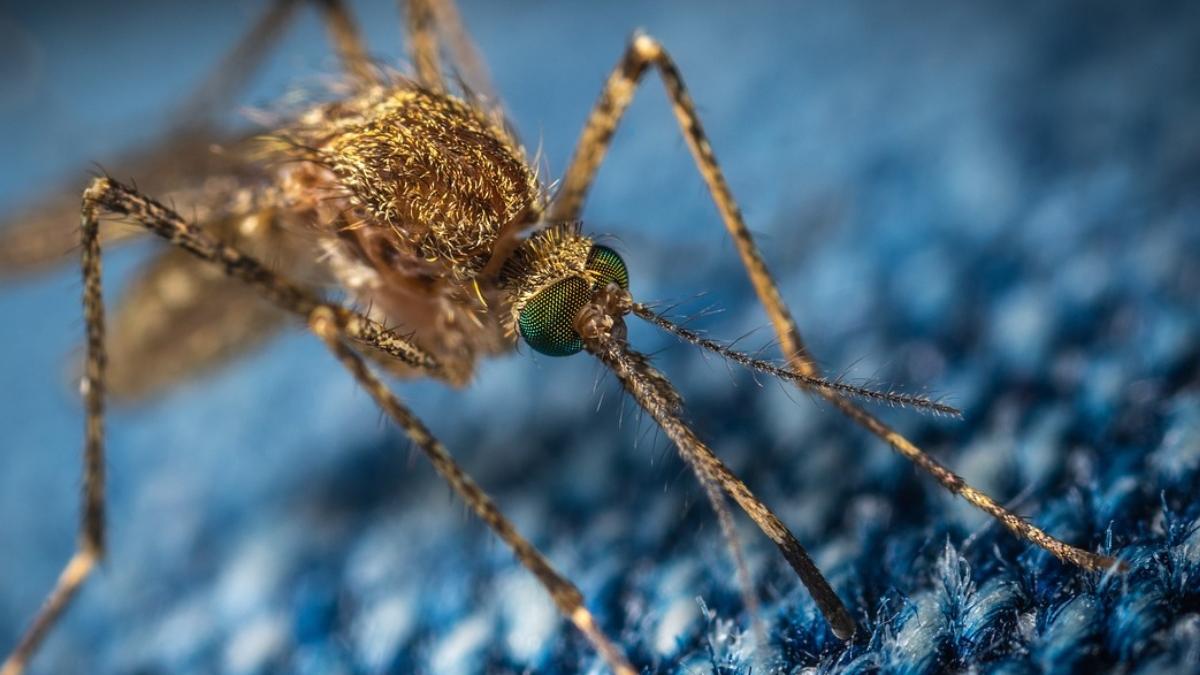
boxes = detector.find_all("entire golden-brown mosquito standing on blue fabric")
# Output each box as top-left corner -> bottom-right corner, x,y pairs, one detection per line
0,0 -> 1121,675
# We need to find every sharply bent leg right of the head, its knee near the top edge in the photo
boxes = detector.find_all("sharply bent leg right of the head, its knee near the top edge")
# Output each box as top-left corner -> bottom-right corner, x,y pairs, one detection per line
547,35 -> 1117,569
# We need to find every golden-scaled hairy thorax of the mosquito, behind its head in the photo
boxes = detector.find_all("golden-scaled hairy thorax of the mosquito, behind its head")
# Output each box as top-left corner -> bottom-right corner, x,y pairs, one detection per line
271,88 -> 544,384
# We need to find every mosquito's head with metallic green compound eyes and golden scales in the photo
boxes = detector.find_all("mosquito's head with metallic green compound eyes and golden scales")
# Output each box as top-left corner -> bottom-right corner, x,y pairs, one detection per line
502,223 -> 632,357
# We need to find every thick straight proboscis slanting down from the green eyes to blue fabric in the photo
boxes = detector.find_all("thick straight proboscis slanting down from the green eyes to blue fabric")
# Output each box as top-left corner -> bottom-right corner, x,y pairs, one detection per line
581,331 -> 854,640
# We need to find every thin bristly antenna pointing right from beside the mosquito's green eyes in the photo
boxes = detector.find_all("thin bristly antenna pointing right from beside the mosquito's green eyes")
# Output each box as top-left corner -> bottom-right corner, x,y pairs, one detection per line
630,303 -> 962,418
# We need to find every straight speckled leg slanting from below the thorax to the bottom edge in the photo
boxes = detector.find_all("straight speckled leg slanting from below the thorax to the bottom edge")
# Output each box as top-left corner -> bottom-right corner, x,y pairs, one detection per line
308,307 -> 635,675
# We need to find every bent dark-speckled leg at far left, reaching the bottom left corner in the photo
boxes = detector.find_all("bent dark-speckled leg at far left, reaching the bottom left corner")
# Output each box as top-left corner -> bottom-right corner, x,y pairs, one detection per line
0,178 -> 437,675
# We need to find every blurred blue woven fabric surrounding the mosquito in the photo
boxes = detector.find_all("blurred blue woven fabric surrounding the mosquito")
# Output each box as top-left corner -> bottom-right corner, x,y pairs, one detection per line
0,0 -> 1200,674
